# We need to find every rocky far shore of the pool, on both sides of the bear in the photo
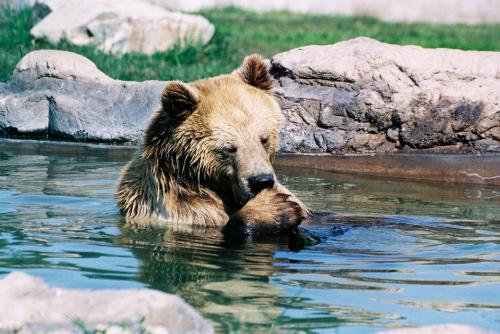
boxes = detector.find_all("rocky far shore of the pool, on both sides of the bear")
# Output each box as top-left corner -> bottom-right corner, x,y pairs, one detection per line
0,38 -> 500,153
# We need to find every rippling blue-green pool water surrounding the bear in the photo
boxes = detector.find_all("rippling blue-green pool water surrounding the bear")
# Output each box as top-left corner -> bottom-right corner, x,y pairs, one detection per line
0,147 -> 500,333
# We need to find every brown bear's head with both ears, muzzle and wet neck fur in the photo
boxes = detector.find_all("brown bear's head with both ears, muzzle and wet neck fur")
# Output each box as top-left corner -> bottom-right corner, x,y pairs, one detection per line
142,55 -> 283,210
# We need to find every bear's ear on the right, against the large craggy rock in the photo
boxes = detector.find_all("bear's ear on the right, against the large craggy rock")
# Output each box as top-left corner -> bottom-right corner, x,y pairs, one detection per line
235,54 -> 273,92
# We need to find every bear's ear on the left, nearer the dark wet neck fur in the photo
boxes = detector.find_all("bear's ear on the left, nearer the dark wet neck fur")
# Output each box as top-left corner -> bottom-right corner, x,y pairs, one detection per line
161,81 -> 198,122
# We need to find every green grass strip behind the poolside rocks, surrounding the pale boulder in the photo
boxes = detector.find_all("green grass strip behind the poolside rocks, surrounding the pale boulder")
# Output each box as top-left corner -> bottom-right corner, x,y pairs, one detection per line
0,8 -> 500,81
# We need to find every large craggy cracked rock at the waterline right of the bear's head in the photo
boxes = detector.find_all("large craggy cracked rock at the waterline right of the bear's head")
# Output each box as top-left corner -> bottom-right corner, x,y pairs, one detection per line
271,38 -> 500,152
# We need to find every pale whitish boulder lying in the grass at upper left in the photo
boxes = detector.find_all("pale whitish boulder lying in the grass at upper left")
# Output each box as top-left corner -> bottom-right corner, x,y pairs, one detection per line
31,0 -> 215,54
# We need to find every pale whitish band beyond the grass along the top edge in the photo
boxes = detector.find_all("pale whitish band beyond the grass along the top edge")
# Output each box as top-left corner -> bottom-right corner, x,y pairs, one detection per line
148,0 -> 500,23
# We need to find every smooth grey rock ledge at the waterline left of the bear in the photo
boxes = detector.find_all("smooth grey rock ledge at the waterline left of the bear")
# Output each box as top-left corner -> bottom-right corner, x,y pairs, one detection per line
0,50 -> 165,142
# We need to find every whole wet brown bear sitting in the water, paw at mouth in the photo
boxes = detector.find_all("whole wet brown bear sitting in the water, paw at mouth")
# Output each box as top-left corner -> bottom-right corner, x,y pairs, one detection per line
117,55 -> 309,235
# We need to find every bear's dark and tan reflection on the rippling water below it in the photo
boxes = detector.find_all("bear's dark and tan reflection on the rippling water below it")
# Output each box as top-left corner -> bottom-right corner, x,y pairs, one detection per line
117,227 -> 292,330
